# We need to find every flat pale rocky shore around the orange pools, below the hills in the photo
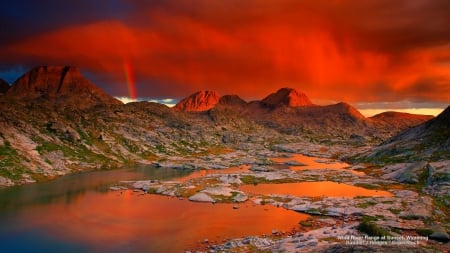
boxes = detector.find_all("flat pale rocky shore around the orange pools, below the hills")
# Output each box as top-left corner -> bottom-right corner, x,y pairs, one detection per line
109,144 -> 449,252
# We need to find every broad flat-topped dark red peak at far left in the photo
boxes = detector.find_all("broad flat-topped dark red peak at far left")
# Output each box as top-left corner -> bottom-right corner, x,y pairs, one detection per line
6,66 -> 120,108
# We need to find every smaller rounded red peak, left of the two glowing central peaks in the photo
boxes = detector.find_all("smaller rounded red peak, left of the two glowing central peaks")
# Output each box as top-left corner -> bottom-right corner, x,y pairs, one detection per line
174,90 -> 220,112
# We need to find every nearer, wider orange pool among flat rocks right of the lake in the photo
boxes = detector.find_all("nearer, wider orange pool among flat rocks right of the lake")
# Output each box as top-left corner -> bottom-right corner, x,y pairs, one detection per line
240,181 -> 392,197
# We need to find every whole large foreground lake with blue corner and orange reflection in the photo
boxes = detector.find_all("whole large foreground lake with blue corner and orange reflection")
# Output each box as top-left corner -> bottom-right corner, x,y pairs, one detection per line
0,166 -> 308,252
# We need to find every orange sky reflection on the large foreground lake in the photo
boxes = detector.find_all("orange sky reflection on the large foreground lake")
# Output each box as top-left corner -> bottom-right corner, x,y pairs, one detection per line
16,190 -> 308,252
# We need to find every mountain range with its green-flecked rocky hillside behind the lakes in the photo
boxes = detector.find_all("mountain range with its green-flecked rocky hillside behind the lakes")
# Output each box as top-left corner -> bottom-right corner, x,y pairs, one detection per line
0,66 -> 448,186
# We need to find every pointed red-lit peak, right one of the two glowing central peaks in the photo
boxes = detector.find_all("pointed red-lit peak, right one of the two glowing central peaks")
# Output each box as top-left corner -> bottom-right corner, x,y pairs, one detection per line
262,88 -> 313,107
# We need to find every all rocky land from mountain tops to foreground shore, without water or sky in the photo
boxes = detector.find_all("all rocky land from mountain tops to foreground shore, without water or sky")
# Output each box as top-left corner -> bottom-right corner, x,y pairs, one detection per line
0,67 -> 450,252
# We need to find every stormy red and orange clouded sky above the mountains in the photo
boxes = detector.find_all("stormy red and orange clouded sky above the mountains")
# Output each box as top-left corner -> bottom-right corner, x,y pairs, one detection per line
0,0 -> 450,109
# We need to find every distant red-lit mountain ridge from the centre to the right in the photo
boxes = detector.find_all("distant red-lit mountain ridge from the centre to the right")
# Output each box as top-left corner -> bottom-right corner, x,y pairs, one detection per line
175,88 -> 433,140
